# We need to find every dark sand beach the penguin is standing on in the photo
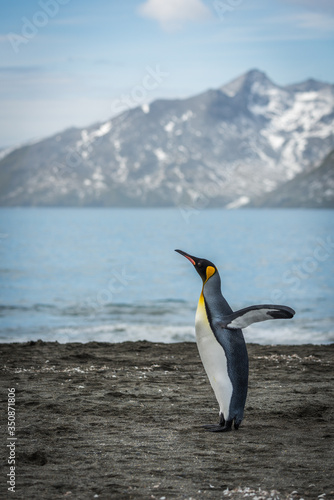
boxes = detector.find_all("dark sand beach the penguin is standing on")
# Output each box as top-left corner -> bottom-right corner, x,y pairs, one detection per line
0,341 -> 334,500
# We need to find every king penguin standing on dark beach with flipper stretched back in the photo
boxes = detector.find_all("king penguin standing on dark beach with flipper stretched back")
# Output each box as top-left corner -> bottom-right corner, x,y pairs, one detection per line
175,250 -> 295,432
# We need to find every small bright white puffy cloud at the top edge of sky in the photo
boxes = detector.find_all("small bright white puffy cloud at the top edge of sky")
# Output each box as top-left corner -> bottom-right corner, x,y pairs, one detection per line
138,0 -> 212,30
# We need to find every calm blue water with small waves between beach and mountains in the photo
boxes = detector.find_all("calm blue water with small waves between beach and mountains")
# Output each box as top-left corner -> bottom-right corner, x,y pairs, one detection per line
0,208 -> 334,344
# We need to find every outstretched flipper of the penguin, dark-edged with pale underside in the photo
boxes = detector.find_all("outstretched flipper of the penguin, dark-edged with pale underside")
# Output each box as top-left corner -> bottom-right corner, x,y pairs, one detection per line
222,304 -> 295,329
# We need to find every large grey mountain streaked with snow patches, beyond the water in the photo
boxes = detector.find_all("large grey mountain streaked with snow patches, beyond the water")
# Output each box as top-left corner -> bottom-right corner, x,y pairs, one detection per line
0,70 -> 334,207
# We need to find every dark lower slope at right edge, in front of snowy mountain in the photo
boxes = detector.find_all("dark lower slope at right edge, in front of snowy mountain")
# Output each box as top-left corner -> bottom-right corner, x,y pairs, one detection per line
249,150 -> 334,208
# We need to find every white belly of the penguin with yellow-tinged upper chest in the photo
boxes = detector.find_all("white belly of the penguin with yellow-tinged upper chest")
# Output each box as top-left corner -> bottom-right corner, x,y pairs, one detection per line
195,295 -> 233,420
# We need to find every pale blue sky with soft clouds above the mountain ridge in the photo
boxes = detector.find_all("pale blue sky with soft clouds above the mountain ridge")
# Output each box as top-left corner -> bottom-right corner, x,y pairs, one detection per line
0,0 -> 334,148
